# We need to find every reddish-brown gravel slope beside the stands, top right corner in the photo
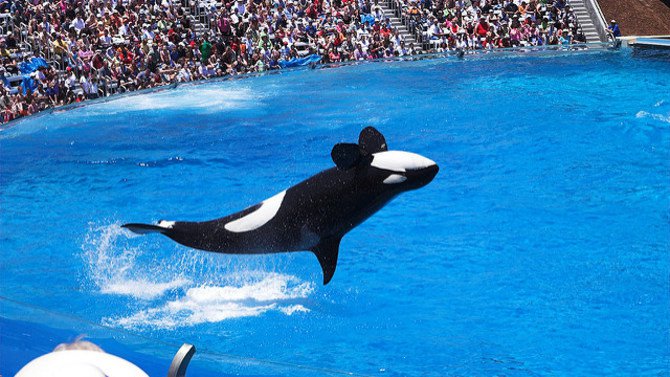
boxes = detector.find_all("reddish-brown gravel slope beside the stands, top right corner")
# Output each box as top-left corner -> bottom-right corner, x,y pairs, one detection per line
598,0 -> 670,36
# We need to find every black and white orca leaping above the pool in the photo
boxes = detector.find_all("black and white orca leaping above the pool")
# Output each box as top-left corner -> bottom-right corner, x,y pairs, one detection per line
122,127 -> 439,285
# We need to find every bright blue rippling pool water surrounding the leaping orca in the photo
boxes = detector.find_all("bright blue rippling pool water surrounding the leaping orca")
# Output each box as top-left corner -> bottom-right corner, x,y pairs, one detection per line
0,50 -> 670,376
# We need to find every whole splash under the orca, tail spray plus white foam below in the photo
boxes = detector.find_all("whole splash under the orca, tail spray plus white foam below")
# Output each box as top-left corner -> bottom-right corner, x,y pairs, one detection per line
83,224 -> 315,329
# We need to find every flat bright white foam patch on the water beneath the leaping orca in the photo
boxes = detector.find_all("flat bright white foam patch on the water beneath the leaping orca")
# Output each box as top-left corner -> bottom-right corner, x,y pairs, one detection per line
103,273 -> 314,329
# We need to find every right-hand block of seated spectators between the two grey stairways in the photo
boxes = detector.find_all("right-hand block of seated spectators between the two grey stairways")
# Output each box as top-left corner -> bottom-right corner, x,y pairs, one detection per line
404,0 -> 586,51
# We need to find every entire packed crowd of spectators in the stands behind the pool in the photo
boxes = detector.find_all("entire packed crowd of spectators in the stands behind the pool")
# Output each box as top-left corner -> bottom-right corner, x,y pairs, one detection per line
0,0 -> 582,123
